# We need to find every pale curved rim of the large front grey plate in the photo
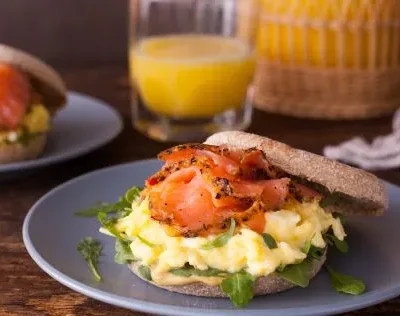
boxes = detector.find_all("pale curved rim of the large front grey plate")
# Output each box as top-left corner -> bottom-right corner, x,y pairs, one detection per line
22,158 -> 400,316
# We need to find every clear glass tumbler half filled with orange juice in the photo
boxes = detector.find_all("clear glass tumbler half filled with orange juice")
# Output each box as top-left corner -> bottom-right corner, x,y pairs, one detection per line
129,0 -> 255,142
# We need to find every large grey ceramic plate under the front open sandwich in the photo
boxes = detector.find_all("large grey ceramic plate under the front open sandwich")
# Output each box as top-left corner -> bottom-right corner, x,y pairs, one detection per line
23,160 -> 400,316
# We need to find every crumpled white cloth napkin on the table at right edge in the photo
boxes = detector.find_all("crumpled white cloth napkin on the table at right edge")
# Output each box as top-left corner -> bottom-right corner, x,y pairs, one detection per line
323,110 -> 400,170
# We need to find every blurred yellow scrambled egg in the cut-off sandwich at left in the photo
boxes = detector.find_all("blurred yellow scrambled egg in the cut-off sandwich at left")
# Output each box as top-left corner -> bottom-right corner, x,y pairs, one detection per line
0,104 -> 50,145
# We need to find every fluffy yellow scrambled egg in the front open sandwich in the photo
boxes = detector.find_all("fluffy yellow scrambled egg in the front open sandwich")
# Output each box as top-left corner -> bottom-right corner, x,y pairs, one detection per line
116,200 -> 346,285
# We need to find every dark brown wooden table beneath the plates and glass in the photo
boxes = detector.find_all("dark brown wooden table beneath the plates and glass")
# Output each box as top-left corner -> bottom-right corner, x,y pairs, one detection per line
0,65 -> 400,316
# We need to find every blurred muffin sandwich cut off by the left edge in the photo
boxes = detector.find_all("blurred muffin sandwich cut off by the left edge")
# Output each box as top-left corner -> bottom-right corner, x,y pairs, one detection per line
0,44 -> 66,164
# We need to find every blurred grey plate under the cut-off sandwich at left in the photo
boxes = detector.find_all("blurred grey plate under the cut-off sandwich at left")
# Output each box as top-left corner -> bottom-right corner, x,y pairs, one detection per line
0,92 -> 123,177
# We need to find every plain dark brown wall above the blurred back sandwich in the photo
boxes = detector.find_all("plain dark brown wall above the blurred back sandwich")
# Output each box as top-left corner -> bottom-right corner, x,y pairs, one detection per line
0,0 -> 128,67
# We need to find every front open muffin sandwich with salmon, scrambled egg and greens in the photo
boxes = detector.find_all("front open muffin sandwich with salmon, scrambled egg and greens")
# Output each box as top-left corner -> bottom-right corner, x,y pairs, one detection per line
94,132 -> 388,307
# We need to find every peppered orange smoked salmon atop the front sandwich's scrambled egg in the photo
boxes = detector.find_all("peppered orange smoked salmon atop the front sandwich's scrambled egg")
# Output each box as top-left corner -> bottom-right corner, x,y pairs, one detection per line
143,144 -> 324,237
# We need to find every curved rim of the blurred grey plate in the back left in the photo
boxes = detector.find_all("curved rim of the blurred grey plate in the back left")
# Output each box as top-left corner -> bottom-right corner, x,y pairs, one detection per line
0,90 -> 124,174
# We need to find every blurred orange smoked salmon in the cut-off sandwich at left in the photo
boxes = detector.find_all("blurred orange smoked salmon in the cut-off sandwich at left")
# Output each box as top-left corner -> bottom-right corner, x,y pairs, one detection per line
0,64 -> 31,130
